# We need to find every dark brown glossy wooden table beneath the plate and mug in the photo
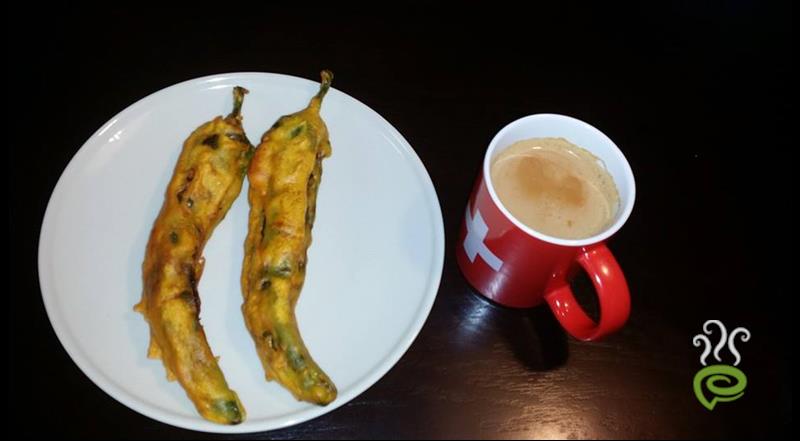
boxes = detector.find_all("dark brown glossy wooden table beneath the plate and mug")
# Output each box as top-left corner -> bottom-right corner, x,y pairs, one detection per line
5,1 -> 797,439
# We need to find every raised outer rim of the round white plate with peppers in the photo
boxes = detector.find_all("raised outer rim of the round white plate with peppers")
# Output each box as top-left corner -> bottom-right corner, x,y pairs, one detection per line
37,71 -> 445,433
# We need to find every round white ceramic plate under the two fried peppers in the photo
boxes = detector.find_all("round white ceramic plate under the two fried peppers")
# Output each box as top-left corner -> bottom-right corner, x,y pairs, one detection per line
39,73 -> 444,433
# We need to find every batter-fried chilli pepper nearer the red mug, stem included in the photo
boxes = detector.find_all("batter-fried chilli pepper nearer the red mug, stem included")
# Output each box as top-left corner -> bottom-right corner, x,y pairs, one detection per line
242,71 -> 337,405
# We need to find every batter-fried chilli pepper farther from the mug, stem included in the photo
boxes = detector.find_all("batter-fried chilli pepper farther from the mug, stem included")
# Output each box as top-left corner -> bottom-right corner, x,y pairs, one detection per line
135,88 -> 253,424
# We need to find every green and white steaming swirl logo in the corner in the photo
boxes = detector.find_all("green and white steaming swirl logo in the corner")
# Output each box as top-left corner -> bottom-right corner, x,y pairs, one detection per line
692,320 -> 750,410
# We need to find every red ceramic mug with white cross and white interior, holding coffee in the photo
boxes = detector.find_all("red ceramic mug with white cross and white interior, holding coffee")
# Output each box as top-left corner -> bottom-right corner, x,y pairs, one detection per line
456,114 -> 636,341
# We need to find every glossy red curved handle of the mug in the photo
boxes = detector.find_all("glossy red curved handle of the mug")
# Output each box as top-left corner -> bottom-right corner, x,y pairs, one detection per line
544,242 -> 631,341
